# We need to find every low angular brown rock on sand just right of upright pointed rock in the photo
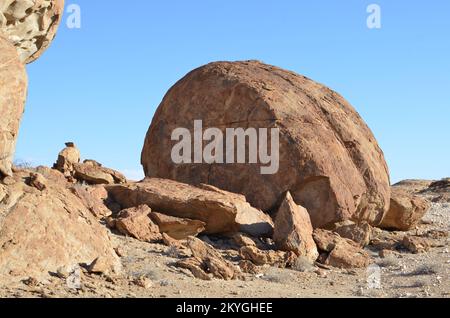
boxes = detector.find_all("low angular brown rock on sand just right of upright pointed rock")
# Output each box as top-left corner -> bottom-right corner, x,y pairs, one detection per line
313,229 -> 370,268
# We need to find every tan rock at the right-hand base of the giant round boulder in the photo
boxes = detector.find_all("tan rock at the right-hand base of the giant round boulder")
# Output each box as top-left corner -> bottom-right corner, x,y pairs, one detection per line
380,188 -> 431,231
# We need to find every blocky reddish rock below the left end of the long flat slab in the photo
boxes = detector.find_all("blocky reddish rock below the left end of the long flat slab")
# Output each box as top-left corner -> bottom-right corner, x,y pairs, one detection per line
115,205 -> 162,242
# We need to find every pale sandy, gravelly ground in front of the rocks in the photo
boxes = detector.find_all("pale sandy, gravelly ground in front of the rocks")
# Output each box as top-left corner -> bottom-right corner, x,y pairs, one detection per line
0,199 -> 450,298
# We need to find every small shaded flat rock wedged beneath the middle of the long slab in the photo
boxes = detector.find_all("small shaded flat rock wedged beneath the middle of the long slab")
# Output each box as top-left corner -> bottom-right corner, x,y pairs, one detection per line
150,212 -> 206,240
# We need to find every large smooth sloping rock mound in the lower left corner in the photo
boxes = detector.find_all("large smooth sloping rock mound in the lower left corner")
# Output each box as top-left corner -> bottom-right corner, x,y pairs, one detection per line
0,172 -> 120,280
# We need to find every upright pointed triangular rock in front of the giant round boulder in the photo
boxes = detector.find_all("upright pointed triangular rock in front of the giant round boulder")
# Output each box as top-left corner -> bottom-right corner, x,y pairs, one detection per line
273,192 -> 319,262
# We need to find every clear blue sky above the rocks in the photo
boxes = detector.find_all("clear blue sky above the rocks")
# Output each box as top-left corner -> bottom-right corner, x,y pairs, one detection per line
16,0 -> 450,181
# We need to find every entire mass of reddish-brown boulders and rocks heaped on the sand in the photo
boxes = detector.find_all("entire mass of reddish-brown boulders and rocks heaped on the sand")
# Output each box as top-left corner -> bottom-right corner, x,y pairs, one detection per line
0,29 -> 438,285
